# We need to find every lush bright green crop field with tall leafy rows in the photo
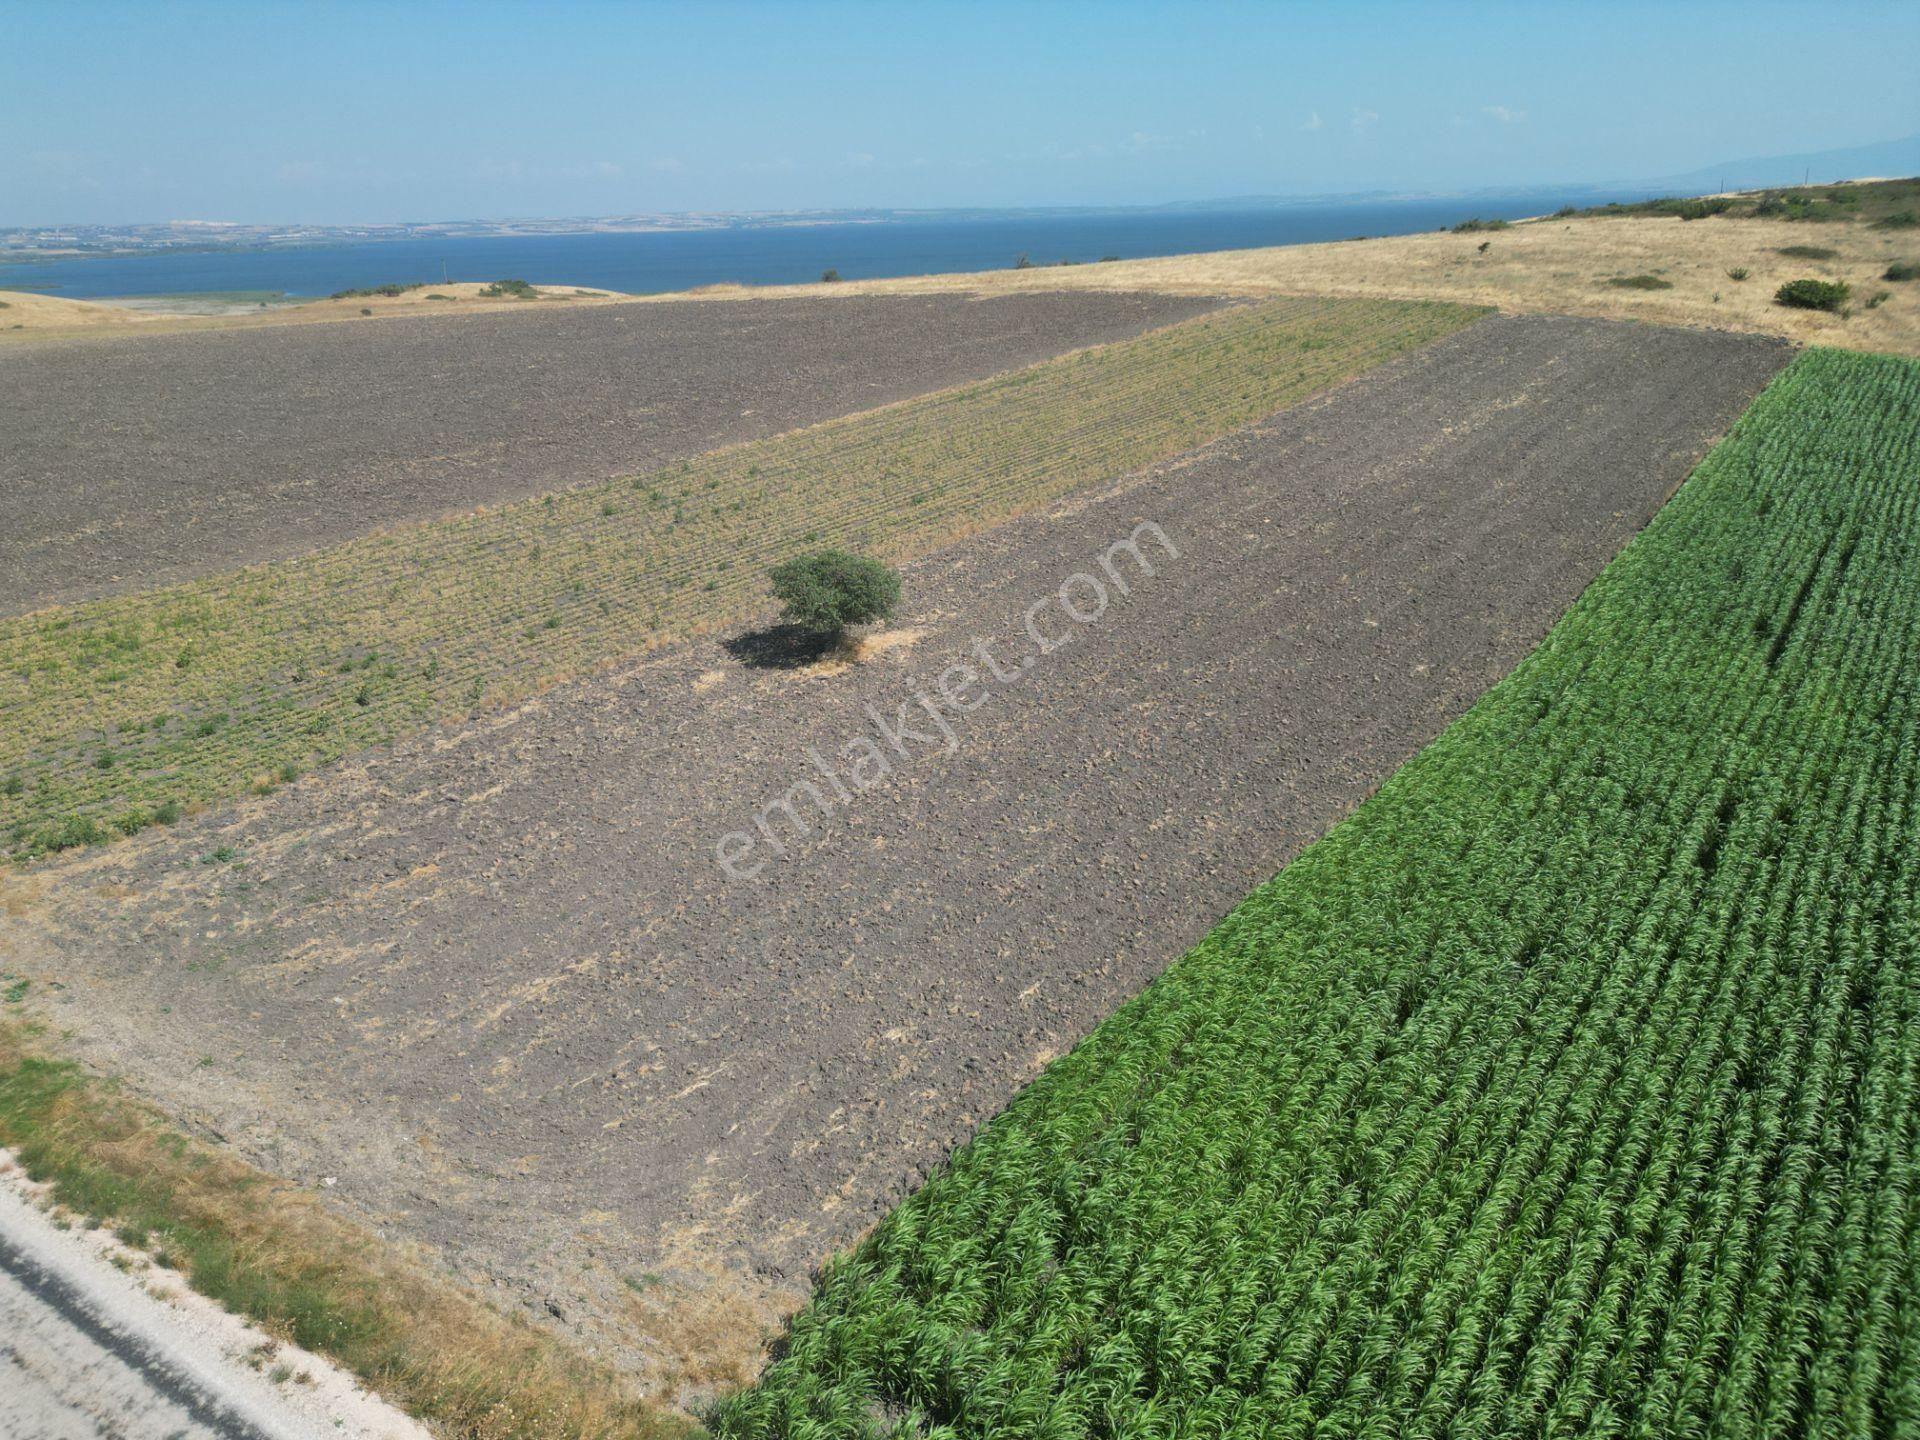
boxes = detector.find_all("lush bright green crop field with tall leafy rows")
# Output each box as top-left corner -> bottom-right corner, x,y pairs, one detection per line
710,351 -> 1920,1440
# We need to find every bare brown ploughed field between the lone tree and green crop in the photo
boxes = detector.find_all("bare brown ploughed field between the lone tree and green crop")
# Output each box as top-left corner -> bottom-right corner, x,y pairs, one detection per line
0,317 -> 1789,1390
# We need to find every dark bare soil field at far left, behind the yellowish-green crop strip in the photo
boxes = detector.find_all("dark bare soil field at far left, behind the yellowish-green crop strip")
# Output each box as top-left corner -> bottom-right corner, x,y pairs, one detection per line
0,294 -> 1215,612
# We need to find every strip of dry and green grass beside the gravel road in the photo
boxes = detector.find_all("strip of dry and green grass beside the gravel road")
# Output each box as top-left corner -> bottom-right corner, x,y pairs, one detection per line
0,1020 -> 699,1440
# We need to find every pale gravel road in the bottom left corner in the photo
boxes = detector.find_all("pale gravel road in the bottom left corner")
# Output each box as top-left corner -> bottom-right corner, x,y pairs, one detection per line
0,1152 -> 428,1440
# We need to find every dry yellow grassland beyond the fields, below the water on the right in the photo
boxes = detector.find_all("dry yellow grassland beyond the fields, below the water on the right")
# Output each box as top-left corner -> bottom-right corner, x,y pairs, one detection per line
647,215 -> 1920,355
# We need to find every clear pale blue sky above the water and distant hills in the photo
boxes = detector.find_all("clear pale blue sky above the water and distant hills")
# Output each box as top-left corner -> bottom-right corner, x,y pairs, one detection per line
0,0 -> 1920,225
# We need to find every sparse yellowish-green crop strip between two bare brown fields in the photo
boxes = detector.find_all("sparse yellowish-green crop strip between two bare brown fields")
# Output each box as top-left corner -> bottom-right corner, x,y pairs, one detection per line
0,300 -> 1482,856
